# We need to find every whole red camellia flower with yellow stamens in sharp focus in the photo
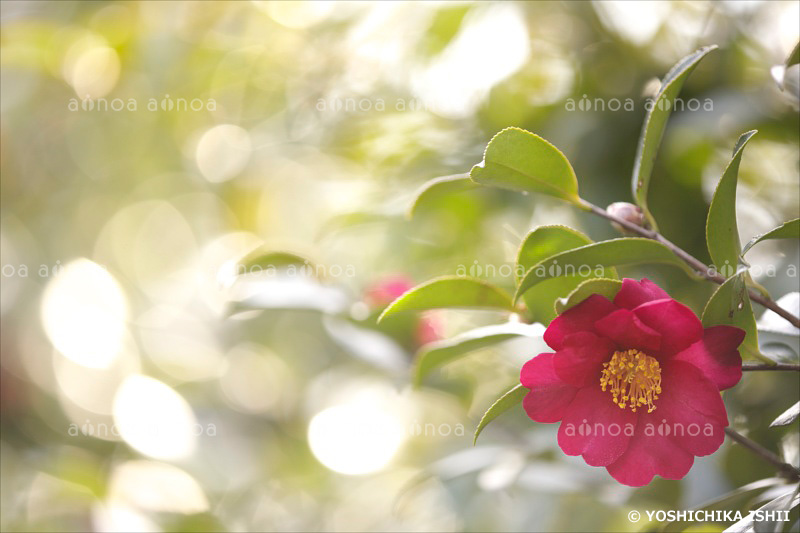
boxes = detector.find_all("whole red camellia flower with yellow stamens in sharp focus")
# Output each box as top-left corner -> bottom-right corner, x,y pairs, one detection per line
520,279 -> 744,487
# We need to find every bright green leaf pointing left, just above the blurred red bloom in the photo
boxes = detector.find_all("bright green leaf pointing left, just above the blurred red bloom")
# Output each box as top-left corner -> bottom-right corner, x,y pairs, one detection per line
378,276 -> 514,322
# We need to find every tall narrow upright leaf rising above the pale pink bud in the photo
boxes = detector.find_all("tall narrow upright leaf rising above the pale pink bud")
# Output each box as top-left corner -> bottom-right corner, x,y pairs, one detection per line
632,45 -> 717,229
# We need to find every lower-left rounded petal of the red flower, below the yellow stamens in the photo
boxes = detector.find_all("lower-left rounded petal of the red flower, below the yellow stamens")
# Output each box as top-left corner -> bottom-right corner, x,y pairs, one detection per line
558,385 -> 636,466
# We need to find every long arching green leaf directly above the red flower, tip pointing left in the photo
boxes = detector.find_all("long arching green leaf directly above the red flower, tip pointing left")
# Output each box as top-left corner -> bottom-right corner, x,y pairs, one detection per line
514,237 -> 698,301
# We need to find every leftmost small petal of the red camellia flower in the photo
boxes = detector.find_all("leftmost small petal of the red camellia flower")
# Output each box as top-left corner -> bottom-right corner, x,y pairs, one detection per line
520,353 -> 577,424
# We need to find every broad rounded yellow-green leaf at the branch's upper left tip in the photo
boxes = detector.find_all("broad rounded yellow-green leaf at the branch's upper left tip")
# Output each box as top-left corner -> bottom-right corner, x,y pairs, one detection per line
470,128 -> 581,204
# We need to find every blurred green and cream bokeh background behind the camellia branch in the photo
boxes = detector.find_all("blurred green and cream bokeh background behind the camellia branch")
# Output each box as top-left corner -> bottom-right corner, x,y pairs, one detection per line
0,1 -> 800,531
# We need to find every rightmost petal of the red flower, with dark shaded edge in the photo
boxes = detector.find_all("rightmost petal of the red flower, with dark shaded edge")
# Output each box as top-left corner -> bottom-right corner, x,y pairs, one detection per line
672,326 -> 745,390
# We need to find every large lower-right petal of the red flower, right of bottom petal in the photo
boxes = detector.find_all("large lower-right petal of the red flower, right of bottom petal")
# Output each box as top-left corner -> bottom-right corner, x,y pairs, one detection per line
643,360 -> 728,456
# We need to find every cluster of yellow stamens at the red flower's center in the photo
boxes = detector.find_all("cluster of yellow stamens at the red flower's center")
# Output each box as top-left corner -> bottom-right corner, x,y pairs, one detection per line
600,350 -> 661,413
